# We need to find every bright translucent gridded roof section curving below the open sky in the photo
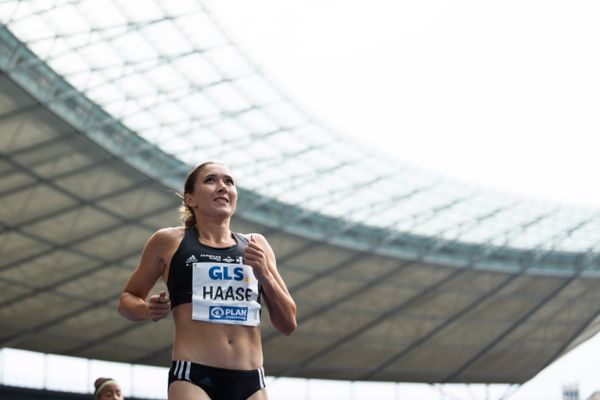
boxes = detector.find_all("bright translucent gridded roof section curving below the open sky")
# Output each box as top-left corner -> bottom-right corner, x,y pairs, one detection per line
0,1 -> 600,255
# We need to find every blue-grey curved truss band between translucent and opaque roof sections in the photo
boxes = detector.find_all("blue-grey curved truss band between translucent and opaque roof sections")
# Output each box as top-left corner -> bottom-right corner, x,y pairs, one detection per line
0,27 -> 600,277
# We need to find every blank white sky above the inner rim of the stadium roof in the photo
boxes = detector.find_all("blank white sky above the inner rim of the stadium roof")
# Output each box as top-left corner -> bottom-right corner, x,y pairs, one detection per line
208,0 -> 600,206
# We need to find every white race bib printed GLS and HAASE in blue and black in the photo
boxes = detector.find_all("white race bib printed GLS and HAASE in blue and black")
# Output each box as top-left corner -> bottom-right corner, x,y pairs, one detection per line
192,262 -> 260,326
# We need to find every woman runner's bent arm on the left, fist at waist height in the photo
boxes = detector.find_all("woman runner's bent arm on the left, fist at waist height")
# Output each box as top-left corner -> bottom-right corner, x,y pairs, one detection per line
118,228 -> 177,321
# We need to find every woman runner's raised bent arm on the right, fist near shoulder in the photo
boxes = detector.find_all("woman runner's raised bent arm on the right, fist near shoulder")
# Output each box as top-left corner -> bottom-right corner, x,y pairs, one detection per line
244,233 -> 297,336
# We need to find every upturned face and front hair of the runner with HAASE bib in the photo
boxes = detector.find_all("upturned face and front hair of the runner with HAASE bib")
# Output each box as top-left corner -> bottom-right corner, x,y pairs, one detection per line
185,163 -> 237,218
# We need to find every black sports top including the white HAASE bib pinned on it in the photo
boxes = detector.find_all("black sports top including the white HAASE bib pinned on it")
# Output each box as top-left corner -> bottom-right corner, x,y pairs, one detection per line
167,227 -> 261,326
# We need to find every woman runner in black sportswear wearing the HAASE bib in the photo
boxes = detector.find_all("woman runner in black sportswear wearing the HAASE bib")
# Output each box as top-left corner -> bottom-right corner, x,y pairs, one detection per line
118,162 -> 296,400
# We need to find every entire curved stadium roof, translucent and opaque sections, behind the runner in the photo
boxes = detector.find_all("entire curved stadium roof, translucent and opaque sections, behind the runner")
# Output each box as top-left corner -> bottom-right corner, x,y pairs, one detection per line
0,0 -> 600,394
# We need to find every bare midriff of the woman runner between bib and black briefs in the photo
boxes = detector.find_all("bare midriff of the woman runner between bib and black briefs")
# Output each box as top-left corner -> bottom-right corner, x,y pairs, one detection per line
172,303 -> 263,370
